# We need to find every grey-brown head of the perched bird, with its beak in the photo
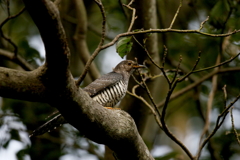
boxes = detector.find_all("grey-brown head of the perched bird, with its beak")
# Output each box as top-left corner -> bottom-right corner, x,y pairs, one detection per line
113,60 -> 145,75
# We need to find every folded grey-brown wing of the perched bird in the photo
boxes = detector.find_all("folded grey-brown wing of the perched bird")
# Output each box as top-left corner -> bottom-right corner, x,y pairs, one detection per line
83,72 -> 123,97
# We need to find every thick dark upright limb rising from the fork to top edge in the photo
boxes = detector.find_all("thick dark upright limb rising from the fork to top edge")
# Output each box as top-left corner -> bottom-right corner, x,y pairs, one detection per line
24,0 -> 72,96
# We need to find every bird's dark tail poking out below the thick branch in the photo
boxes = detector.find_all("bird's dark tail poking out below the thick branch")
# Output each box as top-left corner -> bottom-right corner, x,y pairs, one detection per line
29,114 -> 67,137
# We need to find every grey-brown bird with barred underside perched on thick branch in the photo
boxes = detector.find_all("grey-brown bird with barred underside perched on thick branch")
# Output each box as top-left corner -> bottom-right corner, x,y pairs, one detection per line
29,60 -> 145,137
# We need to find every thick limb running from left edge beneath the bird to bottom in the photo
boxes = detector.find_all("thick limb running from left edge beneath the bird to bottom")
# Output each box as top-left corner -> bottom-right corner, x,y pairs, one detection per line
0,66 -> 153,160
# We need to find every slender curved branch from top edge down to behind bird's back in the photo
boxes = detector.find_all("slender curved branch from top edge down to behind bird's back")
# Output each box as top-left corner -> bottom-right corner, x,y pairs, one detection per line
76,0 -> 106,86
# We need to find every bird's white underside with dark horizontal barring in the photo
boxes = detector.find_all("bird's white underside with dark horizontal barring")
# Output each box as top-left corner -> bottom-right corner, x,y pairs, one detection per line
93,81 -> 127,107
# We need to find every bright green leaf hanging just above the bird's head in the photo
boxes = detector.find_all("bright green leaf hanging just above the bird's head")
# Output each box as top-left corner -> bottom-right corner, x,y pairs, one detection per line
116,37 -> 133,58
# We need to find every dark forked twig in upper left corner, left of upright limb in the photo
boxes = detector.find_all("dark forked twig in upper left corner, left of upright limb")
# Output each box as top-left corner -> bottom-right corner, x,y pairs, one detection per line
0,4 -> 25,56
